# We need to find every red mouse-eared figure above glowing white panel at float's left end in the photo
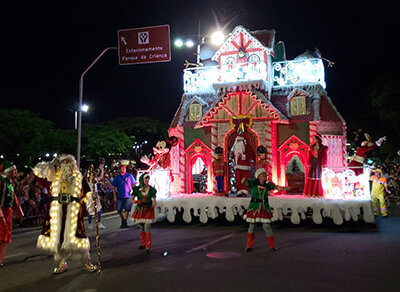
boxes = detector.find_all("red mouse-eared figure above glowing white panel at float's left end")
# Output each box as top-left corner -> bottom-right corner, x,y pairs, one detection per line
140,136 -> 178,198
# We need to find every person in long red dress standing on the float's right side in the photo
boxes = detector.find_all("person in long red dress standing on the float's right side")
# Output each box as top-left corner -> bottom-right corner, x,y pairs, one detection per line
303,135 -> 328,197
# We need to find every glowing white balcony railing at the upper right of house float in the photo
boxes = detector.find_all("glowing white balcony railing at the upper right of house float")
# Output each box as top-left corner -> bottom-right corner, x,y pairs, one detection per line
272,58 -> 326,88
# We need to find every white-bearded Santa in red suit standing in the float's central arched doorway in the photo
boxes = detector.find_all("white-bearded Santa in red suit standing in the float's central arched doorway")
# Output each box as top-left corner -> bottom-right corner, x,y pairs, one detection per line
232,135 -> 251,196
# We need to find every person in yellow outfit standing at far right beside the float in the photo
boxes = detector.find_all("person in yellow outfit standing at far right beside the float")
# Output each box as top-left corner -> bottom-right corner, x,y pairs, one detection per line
370,168 -> 391,218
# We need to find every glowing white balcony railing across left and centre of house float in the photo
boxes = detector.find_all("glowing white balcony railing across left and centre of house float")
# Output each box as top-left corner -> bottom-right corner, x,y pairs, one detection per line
183,63 -> 267,93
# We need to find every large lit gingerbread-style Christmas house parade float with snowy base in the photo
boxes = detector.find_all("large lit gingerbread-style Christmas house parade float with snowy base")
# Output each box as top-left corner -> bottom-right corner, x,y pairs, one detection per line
148,26 -> 375,224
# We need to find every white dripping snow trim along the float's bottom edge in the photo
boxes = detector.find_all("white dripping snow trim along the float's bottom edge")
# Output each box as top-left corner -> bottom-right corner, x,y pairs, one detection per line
155,194 -> 375,225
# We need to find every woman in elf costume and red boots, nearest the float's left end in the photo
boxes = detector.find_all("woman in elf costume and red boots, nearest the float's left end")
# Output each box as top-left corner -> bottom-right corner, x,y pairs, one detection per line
130,173 -> 157,253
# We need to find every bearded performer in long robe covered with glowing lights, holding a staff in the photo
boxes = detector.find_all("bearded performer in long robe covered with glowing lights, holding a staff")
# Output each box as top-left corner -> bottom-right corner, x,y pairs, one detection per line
33,154 -> 98,274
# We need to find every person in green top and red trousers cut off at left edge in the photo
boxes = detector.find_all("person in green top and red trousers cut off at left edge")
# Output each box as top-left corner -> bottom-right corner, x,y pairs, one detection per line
0,161 -> 24,267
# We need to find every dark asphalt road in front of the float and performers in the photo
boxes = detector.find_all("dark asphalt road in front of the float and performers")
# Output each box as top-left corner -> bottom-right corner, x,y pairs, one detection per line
0,208 -> 400,292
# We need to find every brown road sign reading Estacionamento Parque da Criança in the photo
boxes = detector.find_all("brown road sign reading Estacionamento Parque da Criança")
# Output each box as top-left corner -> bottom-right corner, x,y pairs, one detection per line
118,24 -> 171,65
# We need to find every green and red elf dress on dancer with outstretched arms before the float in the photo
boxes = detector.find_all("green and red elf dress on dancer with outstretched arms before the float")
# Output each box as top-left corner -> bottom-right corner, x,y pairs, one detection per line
245,180 -> 276,223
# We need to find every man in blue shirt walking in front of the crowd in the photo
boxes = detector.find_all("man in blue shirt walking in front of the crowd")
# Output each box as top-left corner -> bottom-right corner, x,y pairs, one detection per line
111,164 -> 136,228
